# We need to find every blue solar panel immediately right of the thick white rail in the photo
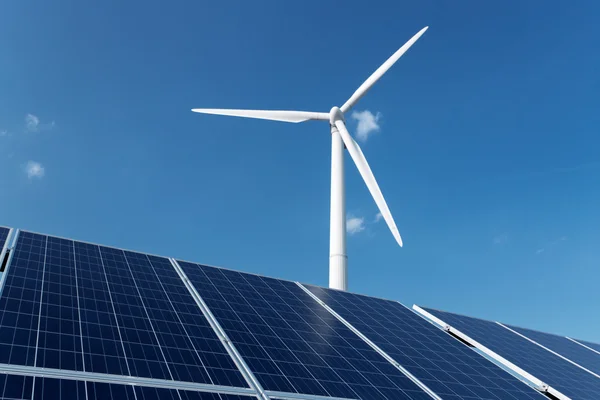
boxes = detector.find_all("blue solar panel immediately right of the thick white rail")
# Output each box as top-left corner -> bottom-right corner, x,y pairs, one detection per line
425,309 -> 600,400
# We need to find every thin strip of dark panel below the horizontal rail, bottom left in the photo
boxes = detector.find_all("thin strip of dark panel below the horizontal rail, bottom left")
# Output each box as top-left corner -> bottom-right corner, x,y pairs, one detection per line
0,374 -> 256,400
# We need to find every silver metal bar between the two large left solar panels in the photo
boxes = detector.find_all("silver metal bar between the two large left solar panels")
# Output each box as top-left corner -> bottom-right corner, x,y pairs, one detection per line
169,258 -> 270,400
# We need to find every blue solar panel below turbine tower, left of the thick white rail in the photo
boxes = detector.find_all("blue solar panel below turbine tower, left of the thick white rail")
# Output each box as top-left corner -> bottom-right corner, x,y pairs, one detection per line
305,285 -> 545,400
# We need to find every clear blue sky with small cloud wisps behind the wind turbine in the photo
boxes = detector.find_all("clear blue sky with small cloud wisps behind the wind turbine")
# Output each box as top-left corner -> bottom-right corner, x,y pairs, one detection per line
0,0 -> 600,342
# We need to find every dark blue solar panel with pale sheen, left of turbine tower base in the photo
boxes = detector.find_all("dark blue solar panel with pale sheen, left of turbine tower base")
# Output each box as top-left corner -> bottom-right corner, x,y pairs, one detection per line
180,262 -> 430,400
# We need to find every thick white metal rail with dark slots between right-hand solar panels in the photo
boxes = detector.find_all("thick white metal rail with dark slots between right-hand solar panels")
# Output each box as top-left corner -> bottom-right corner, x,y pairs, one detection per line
413,304 -> 571,400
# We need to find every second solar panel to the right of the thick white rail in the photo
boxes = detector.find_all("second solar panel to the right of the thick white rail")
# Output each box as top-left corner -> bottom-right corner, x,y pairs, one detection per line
505,324 -> 600,374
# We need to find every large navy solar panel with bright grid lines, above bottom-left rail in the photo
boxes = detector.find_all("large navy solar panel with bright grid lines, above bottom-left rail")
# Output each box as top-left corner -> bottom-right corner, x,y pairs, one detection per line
0,232 -> 249,387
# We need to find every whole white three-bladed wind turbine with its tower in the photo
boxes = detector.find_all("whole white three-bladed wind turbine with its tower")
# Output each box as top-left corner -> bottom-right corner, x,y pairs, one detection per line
192,26 -> 428,290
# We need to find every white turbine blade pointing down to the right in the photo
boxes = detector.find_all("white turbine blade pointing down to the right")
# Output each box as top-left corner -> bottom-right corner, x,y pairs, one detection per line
335,120 -> 402,247
